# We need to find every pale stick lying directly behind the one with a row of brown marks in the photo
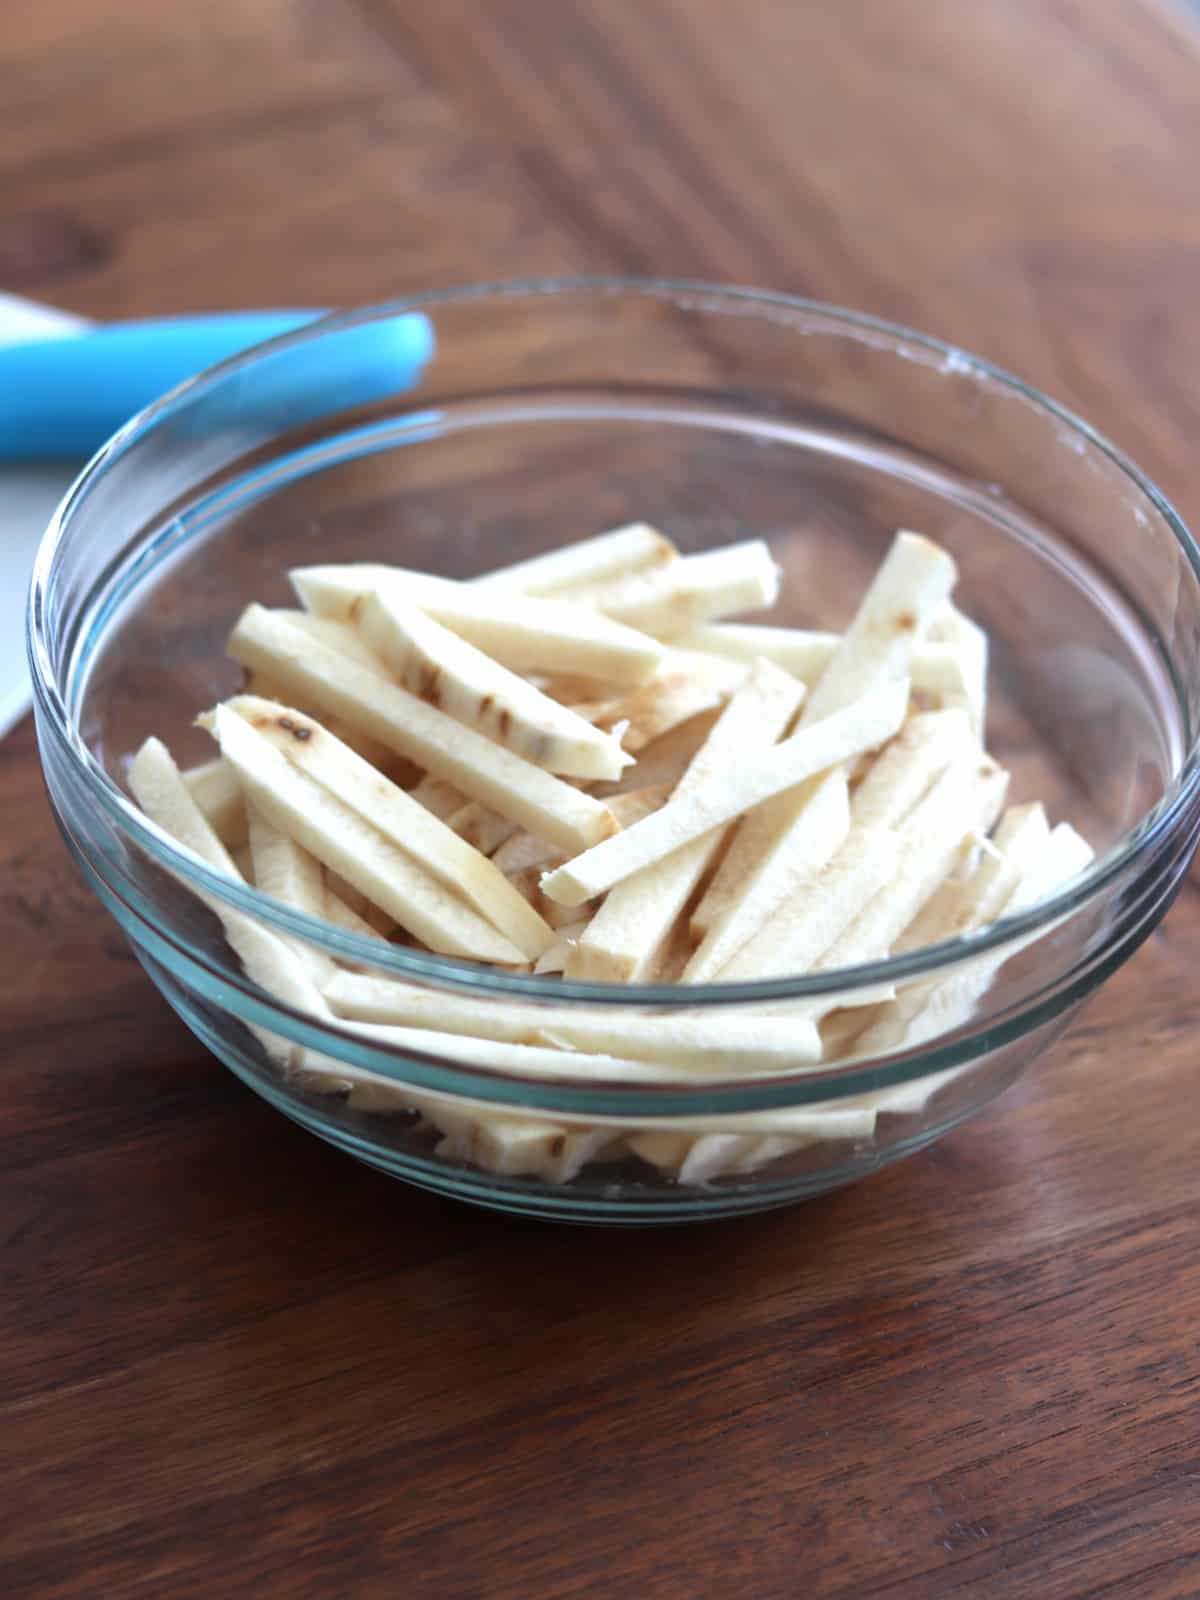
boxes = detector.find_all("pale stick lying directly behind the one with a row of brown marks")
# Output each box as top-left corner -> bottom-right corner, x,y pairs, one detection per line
290,563 -> 662,683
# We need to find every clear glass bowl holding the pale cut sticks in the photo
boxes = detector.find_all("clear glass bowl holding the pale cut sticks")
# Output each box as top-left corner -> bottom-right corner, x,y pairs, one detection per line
30,282 -> 1200,1222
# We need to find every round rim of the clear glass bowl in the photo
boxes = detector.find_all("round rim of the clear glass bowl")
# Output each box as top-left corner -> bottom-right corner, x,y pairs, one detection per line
26,268 -> 1200,1010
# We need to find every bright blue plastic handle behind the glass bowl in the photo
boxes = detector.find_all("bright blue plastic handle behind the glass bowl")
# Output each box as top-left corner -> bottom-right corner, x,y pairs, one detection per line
0,310 -> 434,461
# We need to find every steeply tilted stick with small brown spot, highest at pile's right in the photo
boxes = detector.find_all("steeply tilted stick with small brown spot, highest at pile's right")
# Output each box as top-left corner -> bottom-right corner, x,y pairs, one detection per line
802,533 -> 957,726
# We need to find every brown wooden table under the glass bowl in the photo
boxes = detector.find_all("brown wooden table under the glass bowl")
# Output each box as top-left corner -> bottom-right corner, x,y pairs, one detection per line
0,0 -> 1200,1600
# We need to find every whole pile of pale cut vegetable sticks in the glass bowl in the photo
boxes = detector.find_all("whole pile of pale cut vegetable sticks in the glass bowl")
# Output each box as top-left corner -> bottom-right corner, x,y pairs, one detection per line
128,525 -> 1091,1182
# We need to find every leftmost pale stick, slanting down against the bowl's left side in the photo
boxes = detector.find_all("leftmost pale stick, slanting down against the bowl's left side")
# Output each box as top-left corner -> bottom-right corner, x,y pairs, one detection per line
128,739 -> 333,1072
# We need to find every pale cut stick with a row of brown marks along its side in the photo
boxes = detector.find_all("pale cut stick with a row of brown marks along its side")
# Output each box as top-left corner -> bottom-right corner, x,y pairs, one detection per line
360,592 -> 630,779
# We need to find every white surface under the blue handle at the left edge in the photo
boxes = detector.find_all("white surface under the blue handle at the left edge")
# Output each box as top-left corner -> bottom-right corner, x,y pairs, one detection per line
0,294 -> 83,736
